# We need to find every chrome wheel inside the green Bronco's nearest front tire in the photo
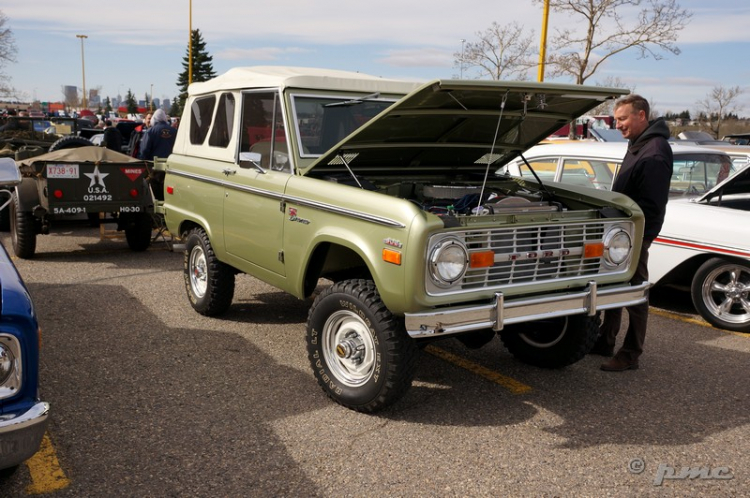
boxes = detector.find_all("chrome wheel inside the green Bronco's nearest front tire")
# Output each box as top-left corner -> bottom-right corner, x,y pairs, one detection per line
321,310 -> 376,387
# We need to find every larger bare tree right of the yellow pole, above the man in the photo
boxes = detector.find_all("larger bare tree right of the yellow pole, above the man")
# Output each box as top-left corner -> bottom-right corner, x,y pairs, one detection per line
534,0 -> 692,85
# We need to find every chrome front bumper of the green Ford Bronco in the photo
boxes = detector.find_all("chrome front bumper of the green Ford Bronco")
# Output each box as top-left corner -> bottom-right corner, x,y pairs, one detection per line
405,281 -> 651,338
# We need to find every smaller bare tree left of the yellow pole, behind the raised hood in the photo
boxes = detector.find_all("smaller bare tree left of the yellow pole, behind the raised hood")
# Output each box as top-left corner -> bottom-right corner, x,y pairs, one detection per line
453,22 -> 536,80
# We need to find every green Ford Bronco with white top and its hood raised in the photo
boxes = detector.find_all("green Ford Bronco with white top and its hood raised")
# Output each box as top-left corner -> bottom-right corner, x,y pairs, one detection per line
163,67 -> 648,412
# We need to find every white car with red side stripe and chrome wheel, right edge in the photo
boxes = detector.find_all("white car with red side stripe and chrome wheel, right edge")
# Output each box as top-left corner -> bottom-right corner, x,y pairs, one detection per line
648,166 -> 750,332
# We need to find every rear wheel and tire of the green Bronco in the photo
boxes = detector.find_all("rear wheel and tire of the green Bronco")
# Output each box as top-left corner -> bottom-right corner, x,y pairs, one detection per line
184,228 -> 234,316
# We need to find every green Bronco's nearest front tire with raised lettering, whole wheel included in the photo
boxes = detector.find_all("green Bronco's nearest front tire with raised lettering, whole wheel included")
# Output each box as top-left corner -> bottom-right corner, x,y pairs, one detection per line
307,280 -> 418,413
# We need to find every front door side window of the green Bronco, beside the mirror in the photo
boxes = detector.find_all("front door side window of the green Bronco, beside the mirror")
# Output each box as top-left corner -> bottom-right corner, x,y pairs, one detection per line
240,92 -> 291,172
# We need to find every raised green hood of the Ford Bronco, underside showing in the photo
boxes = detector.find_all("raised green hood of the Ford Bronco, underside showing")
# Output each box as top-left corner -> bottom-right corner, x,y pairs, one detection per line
303,80 -> 628,175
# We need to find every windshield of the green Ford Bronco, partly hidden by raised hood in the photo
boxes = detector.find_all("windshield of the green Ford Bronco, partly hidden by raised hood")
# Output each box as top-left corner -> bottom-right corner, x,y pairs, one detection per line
292,95 -> 395,157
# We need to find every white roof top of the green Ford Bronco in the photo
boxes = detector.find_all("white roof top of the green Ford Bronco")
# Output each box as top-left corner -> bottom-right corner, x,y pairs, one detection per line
188,66 -> 422,95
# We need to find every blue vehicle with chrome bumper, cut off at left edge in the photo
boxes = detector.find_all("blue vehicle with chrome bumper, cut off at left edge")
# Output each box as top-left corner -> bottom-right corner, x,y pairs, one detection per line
0,158 -> 49,470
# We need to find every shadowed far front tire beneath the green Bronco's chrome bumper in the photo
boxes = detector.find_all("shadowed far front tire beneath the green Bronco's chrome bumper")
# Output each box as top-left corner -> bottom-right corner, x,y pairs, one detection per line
500,315 -> 600,368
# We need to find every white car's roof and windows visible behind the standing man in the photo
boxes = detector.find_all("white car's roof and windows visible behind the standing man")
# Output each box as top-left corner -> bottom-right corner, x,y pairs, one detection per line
497,141 -> 735,196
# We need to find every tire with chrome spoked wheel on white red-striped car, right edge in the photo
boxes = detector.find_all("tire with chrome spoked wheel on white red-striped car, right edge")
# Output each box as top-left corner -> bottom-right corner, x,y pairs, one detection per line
690,258 -> 750,333
